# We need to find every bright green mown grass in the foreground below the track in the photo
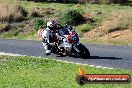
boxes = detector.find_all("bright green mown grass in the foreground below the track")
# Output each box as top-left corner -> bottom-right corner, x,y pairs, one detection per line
0,56 -> 132,88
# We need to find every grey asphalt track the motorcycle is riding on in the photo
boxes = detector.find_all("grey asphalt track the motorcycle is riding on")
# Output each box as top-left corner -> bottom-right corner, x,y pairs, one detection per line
0,39 -> 132,70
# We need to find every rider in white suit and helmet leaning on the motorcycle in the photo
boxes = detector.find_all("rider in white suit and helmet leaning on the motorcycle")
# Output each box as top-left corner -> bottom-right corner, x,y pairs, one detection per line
42,20 -> 60,55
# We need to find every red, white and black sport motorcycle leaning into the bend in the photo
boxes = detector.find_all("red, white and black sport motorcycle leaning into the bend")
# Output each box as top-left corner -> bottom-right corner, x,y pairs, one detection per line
51,25 -> 90,59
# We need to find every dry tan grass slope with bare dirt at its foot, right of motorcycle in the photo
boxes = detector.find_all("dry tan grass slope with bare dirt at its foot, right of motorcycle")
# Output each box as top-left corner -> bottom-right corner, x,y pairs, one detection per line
84,11 -> 132,44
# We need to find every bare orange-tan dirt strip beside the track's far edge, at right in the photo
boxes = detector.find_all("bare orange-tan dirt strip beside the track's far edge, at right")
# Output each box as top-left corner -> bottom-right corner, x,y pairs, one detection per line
84,29 -> 132,45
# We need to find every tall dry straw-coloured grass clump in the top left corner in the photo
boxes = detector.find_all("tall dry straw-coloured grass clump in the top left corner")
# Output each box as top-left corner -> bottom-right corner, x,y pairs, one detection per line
0,0 -> 23,22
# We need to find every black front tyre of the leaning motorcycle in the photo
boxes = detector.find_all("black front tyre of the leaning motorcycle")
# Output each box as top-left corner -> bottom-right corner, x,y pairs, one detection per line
79,44 -> 90,59
